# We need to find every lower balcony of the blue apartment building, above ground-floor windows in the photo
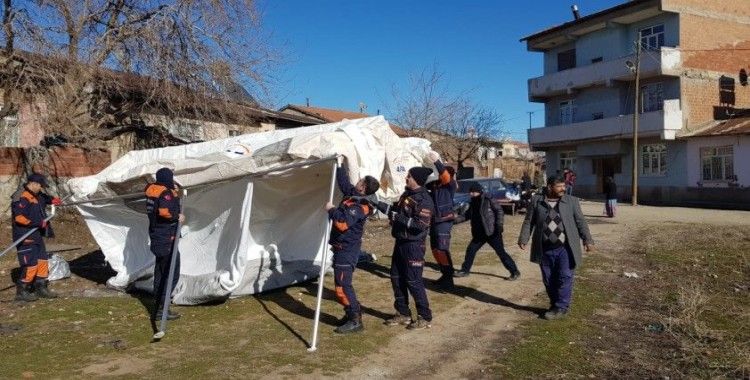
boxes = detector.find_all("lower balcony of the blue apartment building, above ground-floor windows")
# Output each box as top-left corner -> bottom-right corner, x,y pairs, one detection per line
529,99 -> 682,148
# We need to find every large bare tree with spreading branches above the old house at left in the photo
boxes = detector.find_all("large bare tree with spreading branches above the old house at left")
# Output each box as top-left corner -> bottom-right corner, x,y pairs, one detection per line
0,0 -> 278,144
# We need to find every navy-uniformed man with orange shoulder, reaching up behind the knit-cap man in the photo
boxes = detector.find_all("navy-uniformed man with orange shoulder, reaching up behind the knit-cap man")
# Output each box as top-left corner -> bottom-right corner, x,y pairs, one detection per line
426,151 -> 458,290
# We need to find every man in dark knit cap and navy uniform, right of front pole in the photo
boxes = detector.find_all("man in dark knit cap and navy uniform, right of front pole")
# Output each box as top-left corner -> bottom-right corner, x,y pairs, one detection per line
377,167 -> 435,330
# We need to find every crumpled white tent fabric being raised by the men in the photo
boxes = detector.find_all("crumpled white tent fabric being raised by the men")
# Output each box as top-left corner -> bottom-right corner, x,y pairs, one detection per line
68,116 -> 438,305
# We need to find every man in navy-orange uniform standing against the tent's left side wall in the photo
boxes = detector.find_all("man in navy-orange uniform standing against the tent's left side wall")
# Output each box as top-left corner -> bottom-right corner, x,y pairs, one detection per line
145,168 -> 185,321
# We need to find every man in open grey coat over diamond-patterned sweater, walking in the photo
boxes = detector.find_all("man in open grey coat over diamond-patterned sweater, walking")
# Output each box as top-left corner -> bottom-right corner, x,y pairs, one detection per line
518,176 -> 594,319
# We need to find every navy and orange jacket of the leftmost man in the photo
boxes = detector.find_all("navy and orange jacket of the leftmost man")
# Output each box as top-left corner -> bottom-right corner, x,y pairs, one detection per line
11,188 -> 49,245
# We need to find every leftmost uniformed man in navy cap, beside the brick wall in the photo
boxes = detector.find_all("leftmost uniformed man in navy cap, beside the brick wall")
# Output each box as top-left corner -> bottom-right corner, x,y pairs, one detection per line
11,173 -> 62,302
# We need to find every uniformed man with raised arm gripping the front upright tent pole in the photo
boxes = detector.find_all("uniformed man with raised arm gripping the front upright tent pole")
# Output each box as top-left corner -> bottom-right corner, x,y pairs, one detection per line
326,157 -> 380,334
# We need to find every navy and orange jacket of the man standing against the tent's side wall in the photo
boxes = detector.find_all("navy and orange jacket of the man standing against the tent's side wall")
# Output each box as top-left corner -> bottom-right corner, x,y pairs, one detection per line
145,183 -> 181,252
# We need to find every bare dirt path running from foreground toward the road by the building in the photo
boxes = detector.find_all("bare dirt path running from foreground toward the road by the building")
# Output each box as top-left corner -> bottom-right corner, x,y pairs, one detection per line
336,202 -> 750,379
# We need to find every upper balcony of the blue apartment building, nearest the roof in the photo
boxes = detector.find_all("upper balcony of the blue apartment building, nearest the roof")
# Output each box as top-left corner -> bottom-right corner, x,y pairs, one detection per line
529,47 -> 682,102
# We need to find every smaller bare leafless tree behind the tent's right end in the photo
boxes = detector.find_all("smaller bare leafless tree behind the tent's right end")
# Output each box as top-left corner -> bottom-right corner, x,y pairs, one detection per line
392,65 -> 502,167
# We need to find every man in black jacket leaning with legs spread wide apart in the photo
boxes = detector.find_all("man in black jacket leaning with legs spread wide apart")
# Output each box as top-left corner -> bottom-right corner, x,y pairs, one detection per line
454,182 -> 521,281
